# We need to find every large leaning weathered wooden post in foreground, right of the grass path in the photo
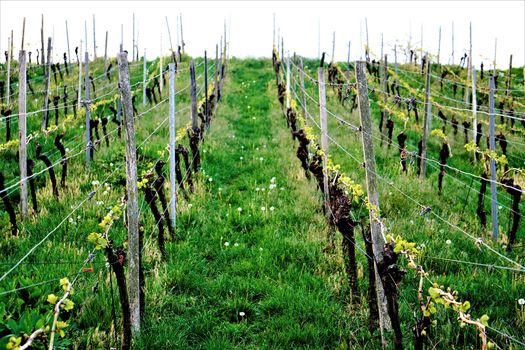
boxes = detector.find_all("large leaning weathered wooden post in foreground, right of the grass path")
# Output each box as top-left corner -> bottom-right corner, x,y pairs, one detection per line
355,61 -> 391,344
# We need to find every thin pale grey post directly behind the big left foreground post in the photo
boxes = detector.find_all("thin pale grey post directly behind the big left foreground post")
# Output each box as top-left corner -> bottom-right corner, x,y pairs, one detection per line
169,62 -> 177,229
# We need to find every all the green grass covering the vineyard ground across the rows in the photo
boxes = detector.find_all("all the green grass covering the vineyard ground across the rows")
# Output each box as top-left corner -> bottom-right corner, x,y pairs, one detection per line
0,52 -> 525,349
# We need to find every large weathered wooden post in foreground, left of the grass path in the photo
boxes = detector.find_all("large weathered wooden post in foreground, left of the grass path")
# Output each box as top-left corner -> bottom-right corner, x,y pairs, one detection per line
117,52 -> 141,335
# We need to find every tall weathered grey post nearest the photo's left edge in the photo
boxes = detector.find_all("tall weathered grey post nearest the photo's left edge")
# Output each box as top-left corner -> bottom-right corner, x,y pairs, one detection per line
18,50 -> 28,220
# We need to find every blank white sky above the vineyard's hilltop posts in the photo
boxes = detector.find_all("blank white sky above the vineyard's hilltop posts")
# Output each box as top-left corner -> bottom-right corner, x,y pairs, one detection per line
0,0 -> 525,69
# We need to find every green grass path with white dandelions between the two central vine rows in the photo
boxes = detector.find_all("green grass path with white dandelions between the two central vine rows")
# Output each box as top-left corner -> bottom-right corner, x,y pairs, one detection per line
137,60 -> 360,349
